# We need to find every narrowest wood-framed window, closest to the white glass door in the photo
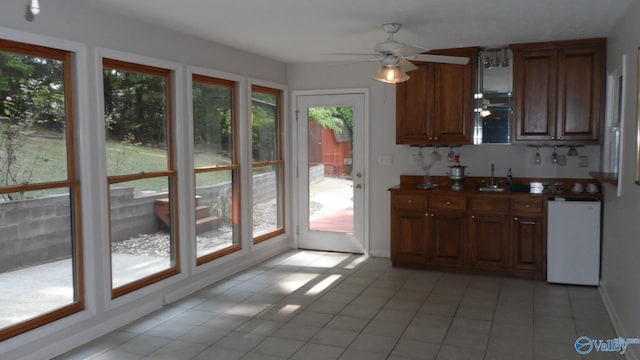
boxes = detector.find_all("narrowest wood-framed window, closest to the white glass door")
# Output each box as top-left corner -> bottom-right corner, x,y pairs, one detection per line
251,85 -> 284,243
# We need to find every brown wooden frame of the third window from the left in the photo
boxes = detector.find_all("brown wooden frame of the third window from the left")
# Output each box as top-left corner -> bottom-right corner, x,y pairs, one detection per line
189,72 -> 242,266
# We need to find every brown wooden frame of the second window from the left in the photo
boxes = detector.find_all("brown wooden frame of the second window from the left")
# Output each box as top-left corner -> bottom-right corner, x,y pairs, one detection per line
100,57 -> 181,299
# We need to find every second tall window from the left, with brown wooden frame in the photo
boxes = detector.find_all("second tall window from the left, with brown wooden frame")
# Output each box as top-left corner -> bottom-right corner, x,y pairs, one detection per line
103,59 -> 179,298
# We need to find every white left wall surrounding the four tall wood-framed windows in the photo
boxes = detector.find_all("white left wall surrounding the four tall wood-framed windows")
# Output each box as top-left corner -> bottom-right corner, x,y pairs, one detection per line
0,0 -> 291,359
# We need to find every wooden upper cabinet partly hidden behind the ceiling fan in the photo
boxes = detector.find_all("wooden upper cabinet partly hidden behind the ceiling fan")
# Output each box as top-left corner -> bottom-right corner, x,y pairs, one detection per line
396,47 -> 478,145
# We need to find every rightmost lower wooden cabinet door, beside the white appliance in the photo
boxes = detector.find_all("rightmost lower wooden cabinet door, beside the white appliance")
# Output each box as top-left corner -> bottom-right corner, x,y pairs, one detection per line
511,216 -> 545,272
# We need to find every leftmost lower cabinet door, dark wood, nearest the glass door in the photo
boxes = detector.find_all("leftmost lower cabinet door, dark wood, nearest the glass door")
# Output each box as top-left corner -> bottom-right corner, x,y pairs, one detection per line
391,209 -> 428,264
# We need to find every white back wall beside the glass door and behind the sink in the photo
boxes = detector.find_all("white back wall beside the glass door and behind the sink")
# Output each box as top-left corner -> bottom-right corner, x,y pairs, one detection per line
288,63 -> 600,256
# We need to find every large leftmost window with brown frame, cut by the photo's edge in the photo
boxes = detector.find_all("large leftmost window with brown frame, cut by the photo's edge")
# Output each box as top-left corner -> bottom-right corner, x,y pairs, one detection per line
0,40 -> 83,341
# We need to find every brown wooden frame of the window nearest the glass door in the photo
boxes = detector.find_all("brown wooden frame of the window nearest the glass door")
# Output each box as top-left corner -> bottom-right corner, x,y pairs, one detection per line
249,83 -> 287,245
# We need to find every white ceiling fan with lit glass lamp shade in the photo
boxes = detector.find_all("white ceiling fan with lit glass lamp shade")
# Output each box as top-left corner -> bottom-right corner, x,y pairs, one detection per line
336,23 -> 469,84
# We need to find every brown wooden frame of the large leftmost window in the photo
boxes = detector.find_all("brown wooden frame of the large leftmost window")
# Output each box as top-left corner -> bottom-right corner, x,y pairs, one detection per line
0,39 -> 86,341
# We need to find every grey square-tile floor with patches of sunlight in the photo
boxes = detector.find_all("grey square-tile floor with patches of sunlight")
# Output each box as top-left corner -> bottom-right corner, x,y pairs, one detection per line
56,251 -> 623,360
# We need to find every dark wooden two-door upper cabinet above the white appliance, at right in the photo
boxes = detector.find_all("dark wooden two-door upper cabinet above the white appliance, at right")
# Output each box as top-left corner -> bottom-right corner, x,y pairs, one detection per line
511,39 -> 606,143
